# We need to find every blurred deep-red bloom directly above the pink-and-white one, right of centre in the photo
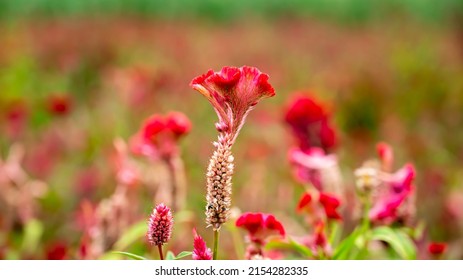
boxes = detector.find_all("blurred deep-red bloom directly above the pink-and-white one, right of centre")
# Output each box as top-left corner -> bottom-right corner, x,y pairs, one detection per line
285,93 -> 337,151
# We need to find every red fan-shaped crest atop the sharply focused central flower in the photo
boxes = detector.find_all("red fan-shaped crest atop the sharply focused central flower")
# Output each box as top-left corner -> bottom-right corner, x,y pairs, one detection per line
190,66 -> 275,142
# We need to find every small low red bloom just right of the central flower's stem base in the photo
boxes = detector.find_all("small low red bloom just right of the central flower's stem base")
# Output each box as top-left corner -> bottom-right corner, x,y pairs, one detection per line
235,213 -> 285,244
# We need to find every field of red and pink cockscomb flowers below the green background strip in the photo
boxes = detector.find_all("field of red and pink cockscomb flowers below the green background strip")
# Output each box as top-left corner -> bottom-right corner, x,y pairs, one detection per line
0,2 -> 463,259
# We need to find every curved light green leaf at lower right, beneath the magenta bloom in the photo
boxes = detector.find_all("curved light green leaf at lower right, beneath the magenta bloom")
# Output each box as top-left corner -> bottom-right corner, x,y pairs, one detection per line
371,226 -> 416,260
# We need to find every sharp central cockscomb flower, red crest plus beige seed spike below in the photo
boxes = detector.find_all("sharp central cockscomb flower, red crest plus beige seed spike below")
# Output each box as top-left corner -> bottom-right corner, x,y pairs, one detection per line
190,66 -> 275,231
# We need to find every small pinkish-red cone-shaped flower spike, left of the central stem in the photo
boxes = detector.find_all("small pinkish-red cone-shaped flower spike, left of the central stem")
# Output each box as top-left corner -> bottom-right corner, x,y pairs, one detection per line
147,203 -> 174,246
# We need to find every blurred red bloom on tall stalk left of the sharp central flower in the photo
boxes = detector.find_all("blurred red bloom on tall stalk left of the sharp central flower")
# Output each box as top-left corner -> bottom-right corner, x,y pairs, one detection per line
130,112 -> 191,159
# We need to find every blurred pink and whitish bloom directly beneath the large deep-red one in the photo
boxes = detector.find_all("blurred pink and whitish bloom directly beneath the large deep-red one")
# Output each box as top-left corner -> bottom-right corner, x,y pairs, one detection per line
288,148 -> 340,191
